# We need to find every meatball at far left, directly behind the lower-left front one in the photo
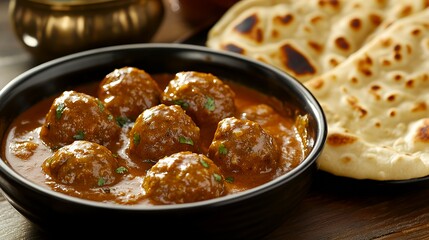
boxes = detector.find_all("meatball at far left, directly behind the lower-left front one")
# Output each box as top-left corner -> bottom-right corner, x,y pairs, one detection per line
40,91 -> 121,149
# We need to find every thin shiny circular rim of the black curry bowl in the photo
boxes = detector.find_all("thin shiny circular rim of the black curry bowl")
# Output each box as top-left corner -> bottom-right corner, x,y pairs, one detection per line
0,43 -> 327,211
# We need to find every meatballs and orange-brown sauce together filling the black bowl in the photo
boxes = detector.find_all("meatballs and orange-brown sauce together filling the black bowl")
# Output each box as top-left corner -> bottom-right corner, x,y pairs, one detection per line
2,67 -> 308,205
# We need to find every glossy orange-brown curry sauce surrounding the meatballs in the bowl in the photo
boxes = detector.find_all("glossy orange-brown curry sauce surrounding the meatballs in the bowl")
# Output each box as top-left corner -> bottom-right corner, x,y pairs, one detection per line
2,74 -> 306,205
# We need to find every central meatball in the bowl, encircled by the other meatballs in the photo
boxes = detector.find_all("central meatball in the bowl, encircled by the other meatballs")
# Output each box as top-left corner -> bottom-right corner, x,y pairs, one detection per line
128,104 -> 200,161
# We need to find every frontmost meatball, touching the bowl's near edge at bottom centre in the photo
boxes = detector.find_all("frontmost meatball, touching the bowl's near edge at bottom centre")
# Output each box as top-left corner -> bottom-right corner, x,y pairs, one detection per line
143,152 -> 226,204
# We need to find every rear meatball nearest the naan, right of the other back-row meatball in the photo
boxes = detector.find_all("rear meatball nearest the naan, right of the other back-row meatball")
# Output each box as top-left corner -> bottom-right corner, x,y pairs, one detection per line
161,71 -> 236,129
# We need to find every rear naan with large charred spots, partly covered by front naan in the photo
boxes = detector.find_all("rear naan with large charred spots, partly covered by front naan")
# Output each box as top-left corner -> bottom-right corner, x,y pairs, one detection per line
206,0 -> 429,82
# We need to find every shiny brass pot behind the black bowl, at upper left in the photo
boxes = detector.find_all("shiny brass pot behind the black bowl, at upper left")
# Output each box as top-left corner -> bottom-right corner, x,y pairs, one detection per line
9,0 -> 164,60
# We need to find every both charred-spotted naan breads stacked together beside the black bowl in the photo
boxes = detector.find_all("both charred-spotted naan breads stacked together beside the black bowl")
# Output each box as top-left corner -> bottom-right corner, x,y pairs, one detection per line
207,0 -> 429,180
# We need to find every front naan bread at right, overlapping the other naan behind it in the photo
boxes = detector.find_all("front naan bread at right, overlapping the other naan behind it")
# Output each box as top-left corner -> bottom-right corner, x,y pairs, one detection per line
304,9 -> 429,180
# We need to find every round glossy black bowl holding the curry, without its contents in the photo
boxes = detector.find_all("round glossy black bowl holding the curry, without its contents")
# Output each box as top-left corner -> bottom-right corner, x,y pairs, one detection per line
0,44 -> 327,239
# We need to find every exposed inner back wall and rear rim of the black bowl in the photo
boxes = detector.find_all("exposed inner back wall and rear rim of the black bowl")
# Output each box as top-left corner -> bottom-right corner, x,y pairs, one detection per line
0,44 -> 326,199
